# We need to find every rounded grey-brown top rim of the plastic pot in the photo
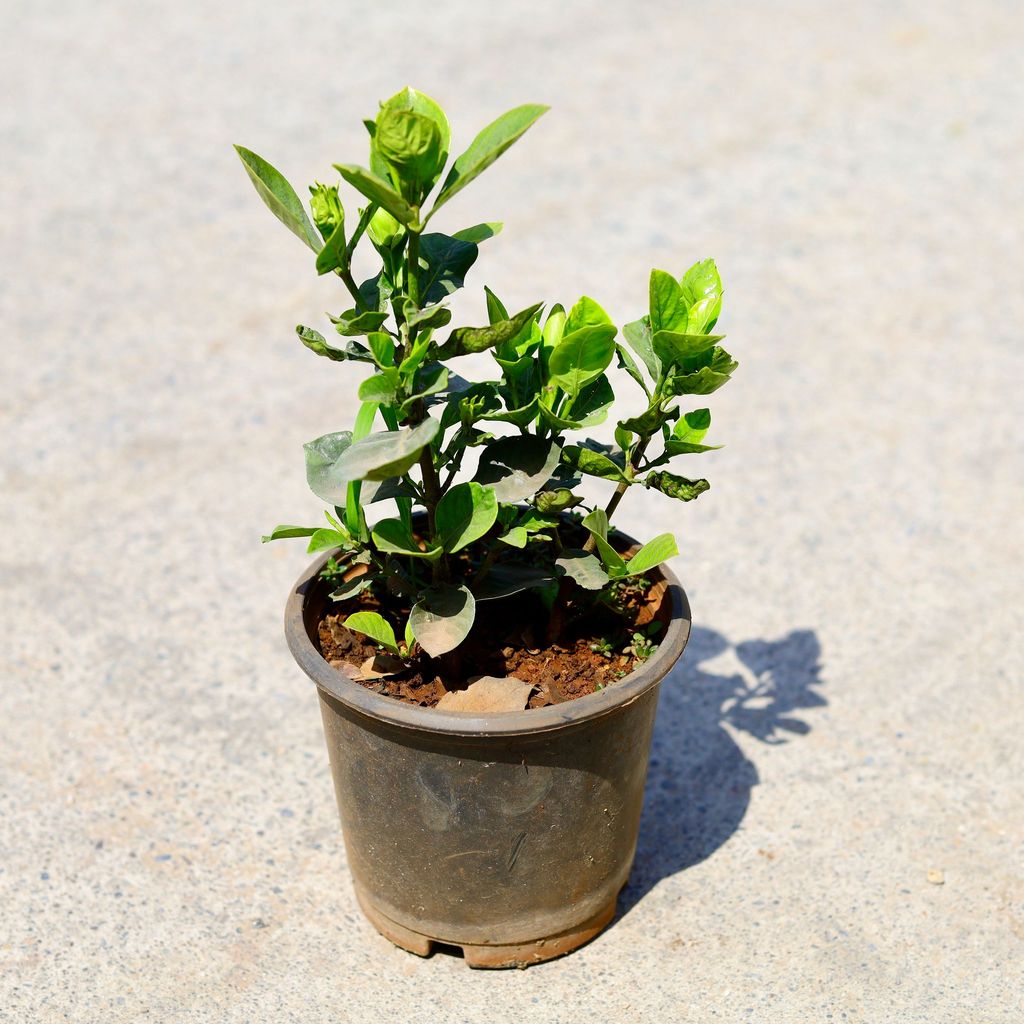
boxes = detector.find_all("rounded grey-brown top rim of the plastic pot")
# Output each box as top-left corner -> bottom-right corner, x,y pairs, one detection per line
285,530 -> 690,736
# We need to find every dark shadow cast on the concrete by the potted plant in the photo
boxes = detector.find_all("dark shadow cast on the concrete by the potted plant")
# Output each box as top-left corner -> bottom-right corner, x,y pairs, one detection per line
618,627 -> 827,918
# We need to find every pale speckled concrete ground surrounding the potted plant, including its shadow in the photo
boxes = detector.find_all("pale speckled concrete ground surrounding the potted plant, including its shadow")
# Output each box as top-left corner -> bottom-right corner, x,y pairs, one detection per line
0,0 -> 1024,1024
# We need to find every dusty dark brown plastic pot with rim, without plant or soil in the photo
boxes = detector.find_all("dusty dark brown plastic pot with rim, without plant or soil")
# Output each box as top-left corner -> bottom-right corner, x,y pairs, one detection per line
285,535 -> 690,967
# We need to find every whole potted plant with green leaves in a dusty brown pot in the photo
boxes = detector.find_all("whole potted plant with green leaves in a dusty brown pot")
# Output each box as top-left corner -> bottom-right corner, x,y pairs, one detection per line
238,88 -> 736,967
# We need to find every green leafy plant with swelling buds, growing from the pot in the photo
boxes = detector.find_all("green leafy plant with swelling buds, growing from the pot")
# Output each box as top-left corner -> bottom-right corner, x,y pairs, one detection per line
237,88 -> 736,658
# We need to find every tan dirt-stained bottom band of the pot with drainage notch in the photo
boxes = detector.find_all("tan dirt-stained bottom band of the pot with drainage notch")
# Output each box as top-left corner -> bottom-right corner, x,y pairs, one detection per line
355,886 -> 617,968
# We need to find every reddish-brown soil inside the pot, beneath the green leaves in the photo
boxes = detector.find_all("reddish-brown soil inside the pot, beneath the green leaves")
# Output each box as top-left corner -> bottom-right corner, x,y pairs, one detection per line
318,552 -> 666,708
